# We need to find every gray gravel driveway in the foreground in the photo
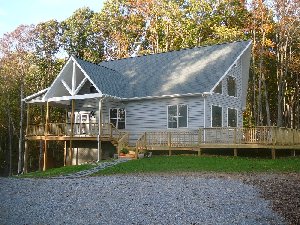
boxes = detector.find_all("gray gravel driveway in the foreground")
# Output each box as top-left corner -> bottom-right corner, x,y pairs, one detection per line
0,174 -> 285,225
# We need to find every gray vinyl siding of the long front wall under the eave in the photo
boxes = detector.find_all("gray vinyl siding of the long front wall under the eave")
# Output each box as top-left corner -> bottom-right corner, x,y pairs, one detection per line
99,96 -> 204,145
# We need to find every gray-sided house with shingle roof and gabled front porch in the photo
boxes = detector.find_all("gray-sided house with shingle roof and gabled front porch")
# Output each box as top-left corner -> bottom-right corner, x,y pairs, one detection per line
24,41 -> 251,168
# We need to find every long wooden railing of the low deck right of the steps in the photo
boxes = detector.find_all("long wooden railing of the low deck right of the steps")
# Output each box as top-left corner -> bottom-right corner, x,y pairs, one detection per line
136,127 -> 300,149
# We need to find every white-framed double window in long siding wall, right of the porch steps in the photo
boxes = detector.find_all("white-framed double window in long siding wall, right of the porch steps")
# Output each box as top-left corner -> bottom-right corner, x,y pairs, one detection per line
168,105 -> 188,128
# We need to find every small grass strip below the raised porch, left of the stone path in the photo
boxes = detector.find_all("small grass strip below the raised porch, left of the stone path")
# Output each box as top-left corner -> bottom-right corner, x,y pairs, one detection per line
18,164 -> 95,178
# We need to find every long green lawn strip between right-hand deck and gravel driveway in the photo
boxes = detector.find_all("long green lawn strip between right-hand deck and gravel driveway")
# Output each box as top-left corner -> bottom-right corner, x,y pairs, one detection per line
94,156 -> 300,176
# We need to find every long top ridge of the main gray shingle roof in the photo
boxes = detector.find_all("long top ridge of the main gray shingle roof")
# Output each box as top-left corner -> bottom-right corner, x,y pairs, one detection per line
99,39 -> 250,65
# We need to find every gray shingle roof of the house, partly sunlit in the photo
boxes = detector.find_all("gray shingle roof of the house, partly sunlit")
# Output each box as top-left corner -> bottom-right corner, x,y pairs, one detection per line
78,41 -> 250,98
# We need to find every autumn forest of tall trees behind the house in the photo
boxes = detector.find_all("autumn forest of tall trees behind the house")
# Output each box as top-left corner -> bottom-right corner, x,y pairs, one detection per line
0,0 -> 300,175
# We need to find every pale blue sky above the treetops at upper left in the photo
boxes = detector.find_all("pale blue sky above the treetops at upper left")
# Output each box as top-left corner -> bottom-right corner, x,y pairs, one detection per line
0,0 -> 105,38
